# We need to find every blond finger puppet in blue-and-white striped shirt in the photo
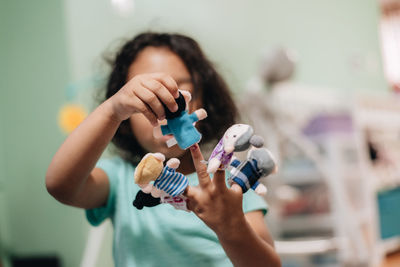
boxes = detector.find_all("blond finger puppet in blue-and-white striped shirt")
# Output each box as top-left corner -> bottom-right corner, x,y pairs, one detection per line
133,153 -> 188,209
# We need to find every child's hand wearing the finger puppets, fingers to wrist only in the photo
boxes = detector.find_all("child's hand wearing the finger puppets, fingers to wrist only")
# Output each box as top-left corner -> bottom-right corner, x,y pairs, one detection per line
185,144 -> 246,235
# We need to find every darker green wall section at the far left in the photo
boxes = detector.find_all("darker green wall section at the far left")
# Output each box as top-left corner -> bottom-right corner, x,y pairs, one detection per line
0,0 -> 87,267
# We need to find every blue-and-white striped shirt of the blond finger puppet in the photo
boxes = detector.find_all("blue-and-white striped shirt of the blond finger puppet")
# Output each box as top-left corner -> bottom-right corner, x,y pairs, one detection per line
153,166 -> 188,197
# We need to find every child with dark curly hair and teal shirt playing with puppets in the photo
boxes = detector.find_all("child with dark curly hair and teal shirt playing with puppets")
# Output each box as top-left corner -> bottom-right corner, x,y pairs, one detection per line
46,33 -> 280,267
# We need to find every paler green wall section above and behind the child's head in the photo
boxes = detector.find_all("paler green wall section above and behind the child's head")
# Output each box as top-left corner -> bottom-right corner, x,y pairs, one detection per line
66,0 -> 388,96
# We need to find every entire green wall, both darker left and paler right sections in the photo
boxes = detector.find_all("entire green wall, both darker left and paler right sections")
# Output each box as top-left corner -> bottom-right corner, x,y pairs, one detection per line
0,0 -> 387,267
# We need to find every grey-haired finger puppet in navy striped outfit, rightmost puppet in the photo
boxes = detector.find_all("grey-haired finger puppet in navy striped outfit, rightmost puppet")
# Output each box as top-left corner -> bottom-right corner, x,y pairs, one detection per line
228,139 -> 277,195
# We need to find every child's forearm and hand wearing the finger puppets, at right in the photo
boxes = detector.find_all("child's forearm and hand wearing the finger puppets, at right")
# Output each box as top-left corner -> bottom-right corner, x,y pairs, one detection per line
186,145 -> 281,267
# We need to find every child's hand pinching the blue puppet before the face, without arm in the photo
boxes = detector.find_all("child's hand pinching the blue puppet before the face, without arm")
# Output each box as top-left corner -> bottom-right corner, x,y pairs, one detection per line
108,73 -> 179,126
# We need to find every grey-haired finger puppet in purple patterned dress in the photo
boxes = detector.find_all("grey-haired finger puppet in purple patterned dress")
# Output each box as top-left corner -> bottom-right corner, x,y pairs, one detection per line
207,124 -> 262,173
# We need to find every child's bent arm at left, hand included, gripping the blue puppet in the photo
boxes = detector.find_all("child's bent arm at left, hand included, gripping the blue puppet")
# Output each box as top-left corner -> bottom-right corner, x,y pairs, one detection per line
46,73 -> 178,208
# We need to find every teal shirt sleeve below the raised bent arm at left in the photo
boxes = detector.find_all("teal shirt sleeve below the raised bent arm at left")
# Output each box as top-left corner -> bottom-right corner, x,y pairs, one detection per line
86,158 -> 121,226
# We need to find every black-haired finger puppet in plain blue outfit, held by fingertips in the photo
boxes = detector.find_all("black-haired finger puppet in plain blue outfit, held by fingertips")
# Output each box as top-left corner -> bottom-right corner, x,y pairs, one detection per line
153,91 -> 207,149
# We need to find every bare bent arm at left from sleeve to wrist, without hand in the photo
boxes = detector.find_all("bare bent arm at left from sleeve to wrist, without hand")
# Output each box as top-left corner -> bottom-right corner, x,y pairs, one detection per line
46,101 -> 120,208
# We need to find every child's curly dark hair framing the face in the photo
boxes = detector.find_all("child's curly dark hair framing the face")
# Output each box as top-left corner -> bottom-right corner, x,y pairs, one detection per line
105,32 -> 238,165
